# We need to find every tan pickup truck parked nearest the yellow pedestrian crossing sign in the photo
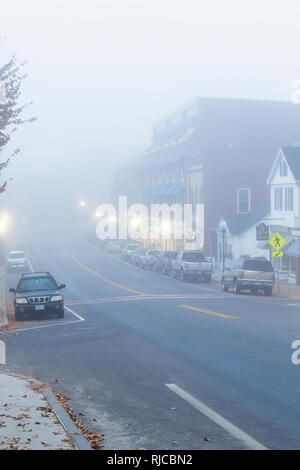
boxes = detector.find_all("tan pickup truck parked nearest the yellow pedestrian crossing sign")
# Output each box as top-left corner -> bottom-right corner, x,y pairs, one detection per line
222,258 -> 275,295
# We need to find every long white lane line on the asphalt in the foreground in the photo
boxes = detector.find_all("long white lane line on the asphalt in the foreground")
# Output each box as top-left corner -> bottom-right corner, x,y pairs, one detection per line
165,384 -> 267,450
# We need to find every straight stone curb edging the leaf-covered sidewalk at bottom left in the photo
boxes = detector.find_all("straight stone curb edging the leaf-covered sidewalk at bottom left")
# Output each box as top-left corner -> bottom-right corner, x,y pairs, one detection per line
43,388 -> 92,450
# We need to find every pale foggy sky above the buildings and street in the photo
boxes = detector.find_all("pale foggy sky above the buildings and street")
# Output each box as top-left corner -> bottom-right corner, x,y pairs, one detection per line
0,0 -> 300,219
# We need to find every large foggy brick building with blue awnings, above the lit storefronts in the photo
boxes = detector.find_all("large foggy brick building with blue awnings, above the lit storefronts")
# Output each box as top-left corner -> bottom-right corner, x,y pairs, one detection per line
114,98 -> 300,256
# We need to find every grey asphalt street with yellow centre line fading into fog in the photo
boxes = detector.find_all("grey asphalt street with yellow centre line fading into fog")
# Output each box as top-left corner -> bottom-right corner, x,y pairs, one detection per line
0,232 -> 300,449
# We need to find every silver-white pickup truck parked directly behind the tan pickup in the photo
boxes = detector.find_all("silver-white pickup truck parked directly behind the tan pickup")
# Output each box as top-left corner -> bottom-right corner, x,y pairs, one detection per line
171,250 -> 213,282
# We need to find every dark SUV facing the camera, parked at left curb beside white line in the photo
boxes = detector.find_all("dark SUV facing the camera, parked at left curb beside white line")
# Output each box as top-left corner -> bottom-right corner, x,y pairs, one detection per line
9,273 -> 66,321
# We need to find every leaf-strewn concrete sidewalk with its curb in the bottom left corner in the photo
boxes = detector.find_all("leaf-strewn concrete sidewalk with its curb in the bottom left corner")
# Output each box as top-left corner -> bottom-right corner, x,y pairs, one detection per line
0,372 -> 90,450
